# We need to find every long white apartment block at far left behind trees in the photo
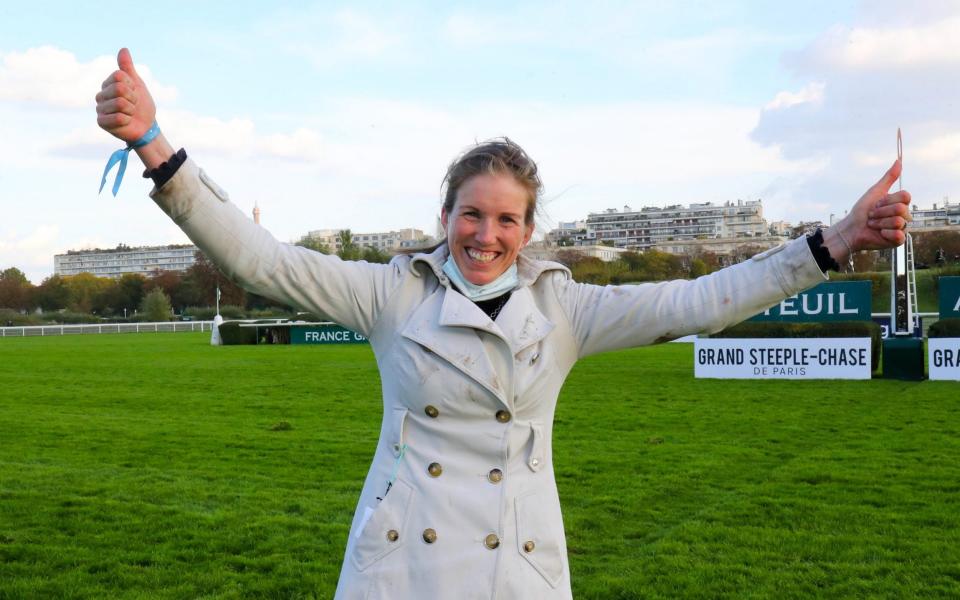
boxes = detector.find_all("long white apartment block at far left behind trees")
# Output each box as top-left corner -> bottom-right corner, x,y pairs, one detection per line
53,245 -> 197,278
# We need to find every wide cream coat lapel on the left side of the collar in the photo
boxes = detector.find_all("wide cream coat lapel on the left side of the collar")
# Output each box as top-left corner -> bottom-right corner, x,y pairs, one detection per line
402,286 -> 510,406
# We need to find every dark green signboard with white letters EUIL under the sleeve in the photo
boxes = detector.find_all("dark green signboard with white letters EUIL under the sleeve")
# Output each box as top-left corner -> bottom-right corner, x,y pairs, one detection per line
749,278 -> 872,323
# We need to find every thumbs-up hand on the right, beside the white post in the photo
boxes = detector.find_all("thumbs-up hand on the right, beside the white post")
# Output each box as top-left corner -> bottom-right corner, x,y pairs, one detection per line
823,159 -> 912,264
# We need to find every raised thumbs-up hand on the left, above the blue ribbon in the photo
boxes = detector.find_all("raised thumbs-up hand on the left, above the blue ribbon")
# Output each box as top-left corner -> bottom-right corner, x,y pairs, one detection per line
96,48 -> 157,143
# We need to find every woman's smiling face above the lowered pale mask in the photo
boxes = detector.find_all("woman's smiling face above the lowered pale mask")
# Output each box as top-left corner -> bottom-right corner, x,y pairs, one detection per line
440,174 -> 533,285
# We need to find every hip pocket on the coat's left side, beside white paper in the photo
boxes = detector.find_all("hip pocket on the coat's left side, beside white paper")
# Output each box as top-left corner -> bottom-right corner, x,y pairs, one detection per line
350,479 -> 413,571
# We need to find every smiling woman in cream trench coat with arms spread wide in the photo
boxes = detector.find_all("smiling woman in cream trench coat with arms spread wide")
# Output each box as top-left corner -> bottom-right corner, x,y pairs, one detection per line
97,49 -> 909,599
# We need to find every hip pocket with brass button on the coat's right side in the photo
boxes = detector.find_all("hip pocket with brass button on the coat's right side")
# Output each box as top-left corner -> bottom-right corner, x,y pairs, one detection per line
514,492 -> 564,588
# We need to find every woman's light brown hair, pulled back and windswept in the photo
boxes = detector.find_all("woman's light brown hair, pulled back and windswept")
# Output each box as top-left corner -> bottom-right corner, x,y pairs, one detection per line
399,137 -> 543,254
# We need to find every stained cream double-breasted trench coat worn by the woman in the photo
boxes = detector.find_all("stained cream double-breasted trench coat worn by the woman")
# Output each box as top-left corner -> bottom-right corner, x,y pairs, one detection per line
151,159 -> 824,600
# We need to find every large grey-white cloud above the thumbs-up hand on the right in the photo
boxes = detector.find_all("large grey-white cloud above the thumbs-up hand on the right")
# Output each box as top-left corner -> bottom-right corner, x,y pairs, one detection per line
752,3 -> 960,214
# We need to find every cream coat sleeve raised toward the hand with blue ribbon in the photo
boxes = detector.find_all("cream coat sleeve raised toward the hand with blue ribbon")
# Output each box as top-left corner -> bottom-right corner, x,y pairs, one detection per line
150,158 -> 409,337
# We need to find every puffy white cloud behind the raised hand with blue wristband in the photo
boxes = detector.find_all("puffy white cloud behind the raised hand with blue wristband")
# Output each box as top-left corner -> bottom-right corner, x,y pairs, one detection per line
0,46 -> 177,109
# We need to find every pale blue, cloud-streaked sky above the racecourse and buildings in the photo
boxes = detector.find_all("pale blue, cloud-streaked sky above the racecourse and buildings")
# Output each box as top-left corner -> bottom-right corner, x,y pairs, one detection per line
0,0 -> 960,283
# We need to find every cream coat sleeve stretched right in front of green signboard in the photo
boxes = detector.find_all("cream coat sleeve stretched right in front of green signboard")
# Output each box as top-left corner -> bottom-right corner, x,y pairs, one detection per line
554,233 -> 826,357
